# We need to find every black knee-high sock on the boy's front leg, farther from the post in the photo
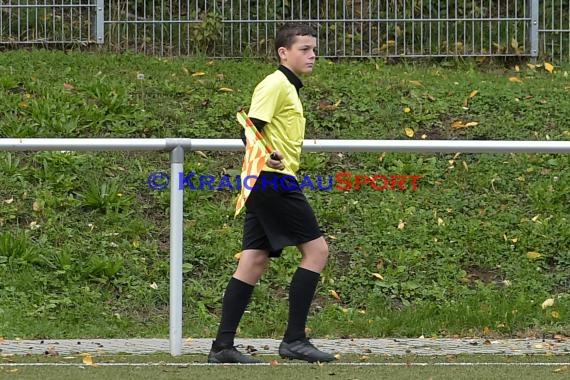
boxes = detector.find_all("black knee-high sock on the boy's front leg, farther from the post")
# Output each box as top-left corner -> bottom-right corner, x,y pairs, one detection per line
283,267 -> 321,343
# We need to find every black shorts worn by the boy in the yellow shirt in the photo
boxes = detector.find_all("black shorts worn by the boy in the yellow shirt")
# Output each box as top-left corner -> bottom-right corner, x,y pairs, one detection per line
242,172 -> 323,257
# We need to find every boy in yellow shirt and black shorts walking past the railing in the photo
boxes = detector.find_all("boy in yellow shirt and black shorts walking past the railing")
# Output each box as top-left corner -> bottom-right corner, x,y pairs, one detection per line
208,24 -> 335,363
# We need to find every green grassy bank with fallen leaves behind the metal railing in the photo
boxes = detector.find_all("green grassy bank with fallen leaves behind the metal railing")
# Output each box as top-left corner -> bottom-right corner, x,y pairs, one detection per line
0,51 -> 570,338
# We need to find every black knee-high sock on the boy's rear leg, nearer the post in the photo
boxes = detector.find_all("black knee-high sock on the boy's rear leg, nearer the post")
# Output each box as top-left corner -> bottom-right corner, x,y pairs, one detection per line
213,277 -> 254,349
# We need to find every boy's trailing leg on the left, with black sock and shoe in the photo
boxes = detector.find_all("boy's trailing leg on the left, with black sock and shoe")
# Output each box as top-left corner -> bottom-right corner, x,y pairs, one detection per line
208,250 -> 269,363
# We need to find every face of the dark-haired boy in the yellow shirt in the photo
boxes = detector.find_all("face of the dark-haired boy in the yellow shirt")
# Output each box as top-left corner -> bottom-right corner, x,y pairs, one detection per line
278,36 -> 317,76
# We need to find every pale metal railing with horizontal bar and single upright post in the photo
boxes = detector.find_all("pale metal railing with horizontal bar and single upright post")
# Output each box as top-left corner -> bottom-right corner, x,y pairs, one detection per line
0,138 -> 570,356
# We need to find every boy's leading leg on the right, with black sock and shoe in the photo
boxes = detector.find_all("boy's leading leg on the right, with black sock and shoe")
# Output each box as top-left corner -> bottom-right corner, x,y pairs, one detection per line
279,237 -> 335,362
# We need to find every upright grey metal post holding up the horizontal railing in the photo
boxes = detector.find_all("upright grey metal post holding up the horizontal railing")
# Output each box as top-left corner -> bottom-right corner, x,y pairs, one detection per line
170,146 -> 184,356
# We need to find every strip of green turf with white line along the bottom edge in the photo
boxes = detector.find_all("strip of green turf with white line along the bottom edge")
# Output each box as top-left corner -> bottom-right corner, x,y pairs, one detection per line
0,355 -> 568,379
